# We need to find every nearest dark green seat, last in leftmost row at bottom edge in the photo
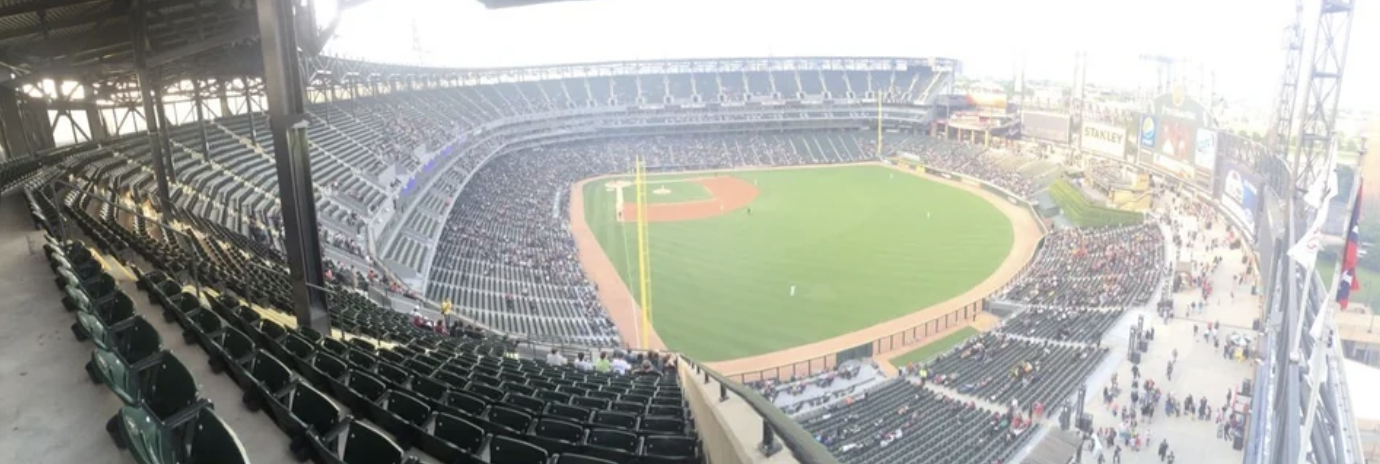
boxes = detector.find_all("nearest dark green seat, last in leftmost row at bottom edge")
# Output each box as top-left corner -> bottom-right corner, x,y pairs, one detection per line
119,406 -> 250,464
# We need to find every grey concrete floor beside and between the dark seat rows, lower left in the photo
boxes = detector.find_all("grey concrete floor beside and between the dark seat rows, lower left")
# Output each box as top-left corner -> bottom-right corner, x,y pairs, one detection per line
0,195 -> 294,464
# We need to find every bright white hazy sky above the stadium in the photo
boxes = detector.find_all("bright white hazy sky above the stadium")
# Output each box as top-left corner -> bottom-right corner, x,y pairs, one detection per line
331,0 -> 1380,110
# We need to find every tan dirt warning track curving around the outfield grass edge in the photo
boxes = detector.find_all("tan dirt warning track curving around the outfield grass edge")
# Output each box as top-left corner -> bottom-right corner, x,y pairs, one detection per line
725,160 -> 1049,383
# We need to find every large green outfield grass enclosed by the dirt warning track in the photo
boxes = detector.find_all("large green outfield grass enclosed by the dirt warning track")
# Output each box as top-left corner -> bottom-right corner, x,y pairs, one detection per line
584,166 -> 1014,360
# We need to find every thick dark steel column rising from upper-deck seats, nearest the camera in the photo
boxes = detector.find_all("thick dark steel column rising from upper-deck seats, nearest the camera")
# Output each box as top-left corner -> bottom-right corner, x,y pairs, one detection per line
257,0 -> 330,334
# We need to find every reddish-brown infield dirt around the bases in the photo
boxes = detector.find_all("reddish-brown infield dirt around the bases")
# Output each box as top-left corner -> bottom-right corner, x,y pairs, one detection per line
618,175 -> 760,222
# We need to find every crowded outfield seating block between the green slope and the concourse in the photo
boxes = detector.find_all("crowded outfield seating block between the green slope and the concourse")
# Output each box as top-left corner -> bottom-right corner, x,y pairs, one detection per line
1003,224 -> 1167,308
